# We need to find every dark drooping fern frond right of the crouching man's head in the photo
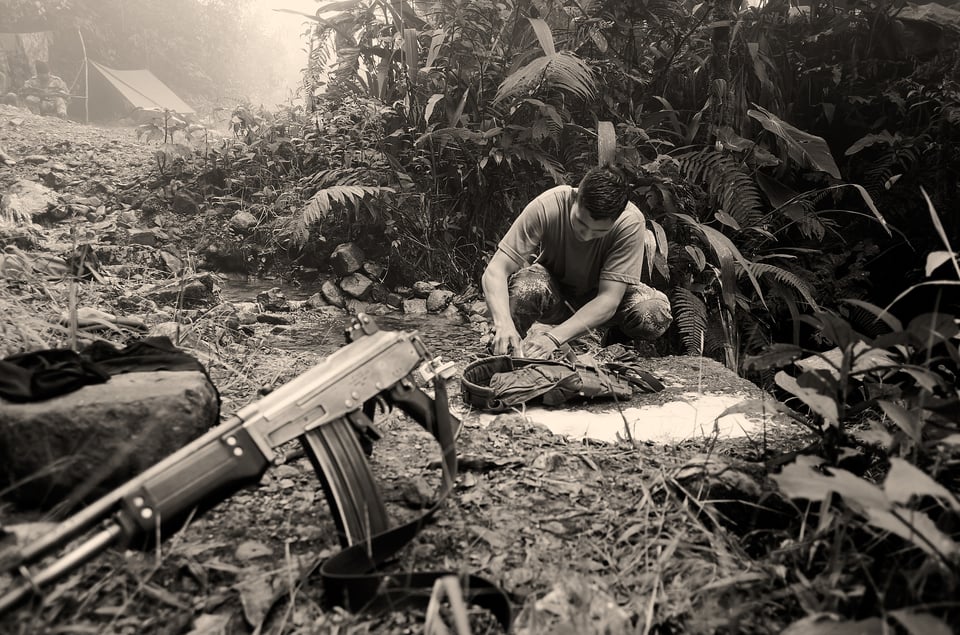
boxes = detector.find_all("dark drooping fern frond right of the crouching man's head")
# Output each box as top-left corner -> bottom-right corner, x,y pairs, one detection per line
677,149 -> 763,229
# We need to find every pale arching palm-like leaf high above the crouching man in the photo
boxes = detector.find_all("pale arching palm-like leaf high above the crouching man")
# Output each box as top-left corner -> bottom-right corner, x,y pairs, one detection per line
493,51 -> 597,104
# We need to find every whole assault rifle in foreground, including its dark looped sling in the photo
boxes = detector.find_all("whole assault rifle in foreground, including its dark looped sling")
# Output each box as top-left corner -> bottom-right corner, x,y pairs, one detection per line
0,314 -> 510,629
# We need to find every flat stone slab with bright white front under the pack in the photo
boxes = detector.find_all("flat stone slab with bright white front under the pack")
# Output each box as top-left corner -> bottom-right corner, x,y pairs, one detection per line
462,356 -> 795,444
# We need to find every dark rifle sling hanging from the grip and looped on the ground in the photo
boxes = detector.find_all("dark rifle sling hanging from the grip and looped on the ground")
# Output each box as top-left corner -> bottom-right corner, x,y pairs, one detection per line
316,380 -> 513,632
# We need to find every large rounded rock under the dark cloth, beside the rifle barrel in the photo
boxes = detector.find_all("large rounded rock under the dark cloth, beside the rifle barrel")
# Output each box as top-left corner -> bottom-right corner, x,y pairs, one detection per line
0,371 -> 219,508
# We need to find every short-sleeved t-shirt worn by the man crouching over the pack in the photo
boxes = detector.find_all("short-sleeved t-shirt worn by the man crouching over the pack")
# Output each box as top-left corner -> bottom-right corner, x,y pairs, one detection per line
497,185 -> 645,308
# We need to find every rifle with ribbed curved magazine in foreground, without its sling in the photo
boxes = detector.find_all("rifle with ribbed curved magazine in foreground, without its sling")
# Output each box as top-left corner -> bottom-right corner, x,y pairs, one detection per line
0,314 -> 446,614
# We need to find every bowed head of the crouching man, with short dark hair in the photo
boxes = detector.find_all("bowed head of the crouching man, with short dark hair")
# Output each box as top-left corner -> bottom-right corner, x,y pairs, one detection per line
571,163 -> 630,240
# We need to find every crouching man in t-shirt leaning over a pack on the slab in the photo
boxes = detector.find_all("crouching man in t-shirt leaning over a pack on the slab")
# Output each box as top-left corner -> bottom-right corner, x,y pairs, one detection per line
482,164 -> 673,358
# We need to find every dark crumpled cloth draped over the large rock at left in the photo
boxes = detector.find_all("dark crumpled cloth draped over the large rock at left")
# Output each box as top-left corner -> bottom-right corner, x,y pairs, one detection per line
0,337 -> 209,403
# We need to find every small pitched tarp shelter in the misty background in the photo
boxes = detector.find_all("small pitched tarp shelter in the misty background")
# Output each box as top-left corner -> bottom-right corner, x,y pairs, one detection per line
87,60 -> 194,121
